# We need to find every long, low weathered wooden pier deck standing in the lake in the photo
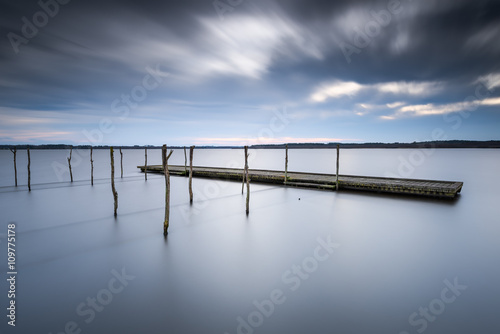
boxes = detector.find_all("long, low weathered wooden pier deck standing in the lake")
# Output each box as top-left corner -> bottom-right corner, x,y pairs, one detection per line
137,165 -> 463,198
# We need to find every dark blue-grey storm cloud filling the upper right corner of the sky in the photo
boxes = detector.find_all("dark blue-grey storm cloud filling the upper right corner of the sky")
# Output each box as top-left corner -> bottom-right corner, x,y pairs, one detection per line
272,1 -> 500,81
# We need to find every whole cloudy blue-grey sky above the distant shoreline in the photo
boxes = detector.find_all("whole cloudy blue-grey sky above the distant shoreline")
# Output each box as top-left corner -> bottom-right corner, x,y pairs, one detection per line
0,0 -> 500,145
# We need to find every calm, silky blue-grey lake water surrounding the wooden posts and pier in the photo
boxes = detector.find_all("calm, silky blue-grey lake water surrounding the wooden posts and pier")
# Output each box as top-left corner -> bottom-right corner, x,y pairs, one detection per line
0,149 -> 500,334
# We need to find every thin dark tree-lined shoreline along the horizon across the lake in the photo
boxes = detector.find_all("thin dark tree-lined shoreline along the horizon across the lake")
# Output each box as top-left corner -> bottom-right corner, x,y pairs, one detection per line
0,140 -> 500,150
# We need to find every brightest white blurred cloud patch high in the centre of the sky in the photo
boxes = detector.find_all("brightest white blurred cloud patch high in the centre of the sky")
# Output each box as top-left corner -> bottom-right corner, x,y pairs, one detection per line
176,15 -> 323,79
